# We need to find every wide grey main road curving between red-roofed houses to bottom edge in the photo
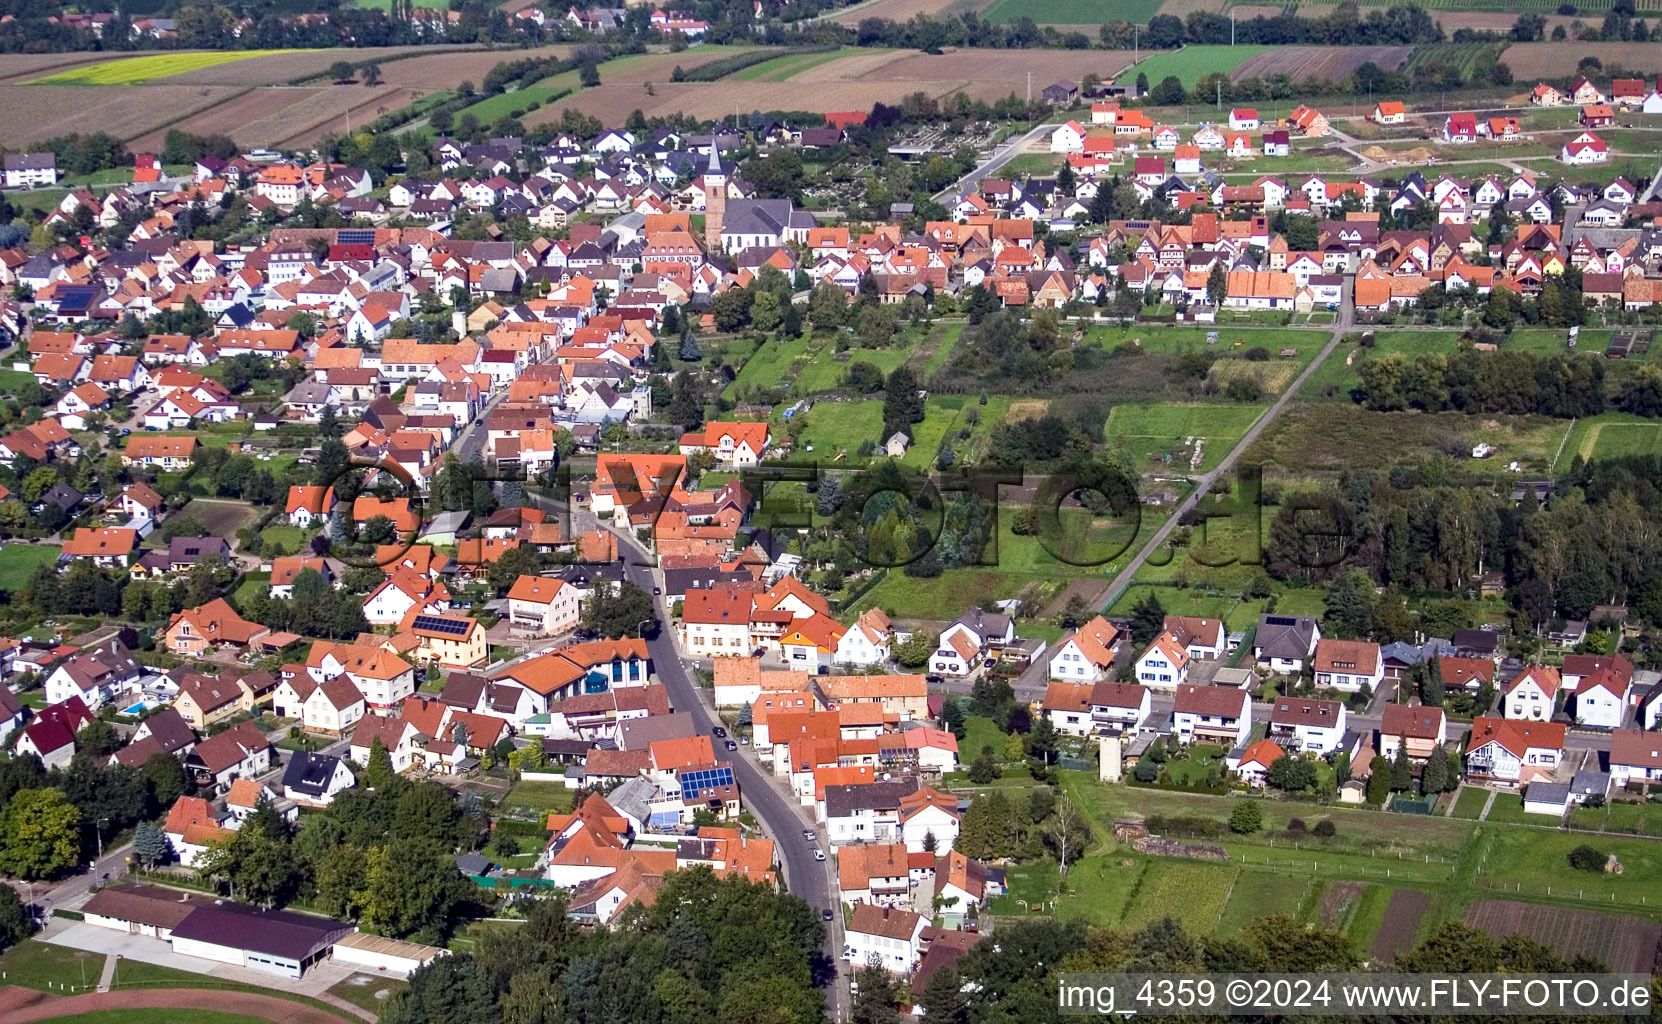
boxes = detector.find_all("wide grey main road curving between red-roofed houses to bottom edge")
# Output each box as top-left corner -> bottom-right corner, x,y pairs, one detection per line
613,530 -> 844,1021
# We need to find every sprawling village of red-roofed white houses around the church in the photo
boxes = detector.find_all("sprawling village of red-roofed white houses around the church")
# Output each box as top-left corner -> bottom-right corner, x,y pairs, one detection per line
0,61 -> 1662,1019
